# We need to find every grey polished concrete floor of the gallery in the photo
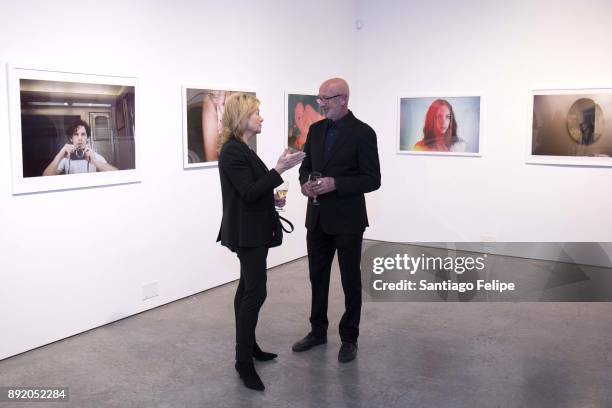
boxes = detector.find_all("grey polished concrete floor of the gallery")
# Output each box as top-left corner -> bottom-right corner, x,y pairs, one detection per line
0,245 -> 612,408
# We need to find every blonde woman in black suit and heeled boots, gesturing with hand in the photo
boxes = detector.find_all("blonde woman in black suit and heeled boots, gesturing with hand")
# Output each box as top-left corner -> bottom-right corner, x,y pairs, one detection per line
217,93 -> 304,391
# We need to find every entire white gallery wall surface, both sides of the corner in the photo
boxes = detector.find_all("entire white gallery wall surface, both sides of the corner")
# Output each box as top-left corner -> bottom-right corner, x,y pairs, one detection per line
0,0 -> 612,359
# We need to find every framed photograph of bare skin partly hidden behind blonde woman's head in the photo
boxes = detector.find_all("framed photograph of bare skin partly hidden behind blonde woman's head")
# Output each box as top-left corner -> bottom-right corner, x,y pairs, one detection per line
182,85 -> 257,169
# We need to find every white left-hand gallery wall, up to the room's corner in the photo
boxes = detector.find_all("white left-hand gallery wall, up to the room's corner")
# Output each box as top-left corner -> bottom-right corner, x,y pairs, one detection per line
0,0 -> 356,359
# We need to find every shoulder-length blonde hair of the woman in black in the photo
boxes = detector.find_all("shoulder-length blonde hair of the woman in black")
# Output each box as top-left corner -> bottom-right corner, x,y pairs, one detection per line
219,92 -> 259,150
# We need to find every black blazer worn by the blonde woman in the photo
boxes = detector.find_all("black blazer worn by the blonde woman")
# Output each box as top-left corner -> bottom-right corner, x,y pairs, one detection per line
217,139 -> 283,251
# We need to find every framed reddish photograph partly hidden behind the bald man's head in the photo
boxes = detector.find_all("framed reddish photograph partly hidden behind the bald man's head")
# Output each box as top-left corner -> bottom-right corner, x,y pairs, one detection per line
285,92 -> 325,150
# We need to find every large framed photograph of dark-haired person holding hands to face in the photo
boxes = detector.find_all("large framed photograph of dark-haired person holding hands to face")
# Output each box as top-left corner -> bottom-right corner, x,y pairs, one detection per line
7,65 -> 140,194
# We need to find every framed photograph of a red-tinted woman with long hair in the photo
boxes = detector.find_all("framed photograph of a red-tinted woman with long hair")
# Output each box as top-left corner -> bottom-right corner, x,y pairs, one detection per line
397,94 -> 482,156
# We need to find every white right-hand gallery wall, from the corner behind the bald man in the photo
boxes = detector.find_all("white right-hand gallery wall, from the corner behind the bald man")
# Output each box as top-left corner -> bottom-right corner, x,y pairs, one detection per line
352,0 -> 612,245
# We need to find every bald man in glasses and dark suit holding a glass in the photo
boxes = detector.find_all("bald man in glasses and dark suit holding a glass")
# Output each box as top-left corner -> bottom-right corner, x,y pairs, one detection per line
292,78 -> 380,363
